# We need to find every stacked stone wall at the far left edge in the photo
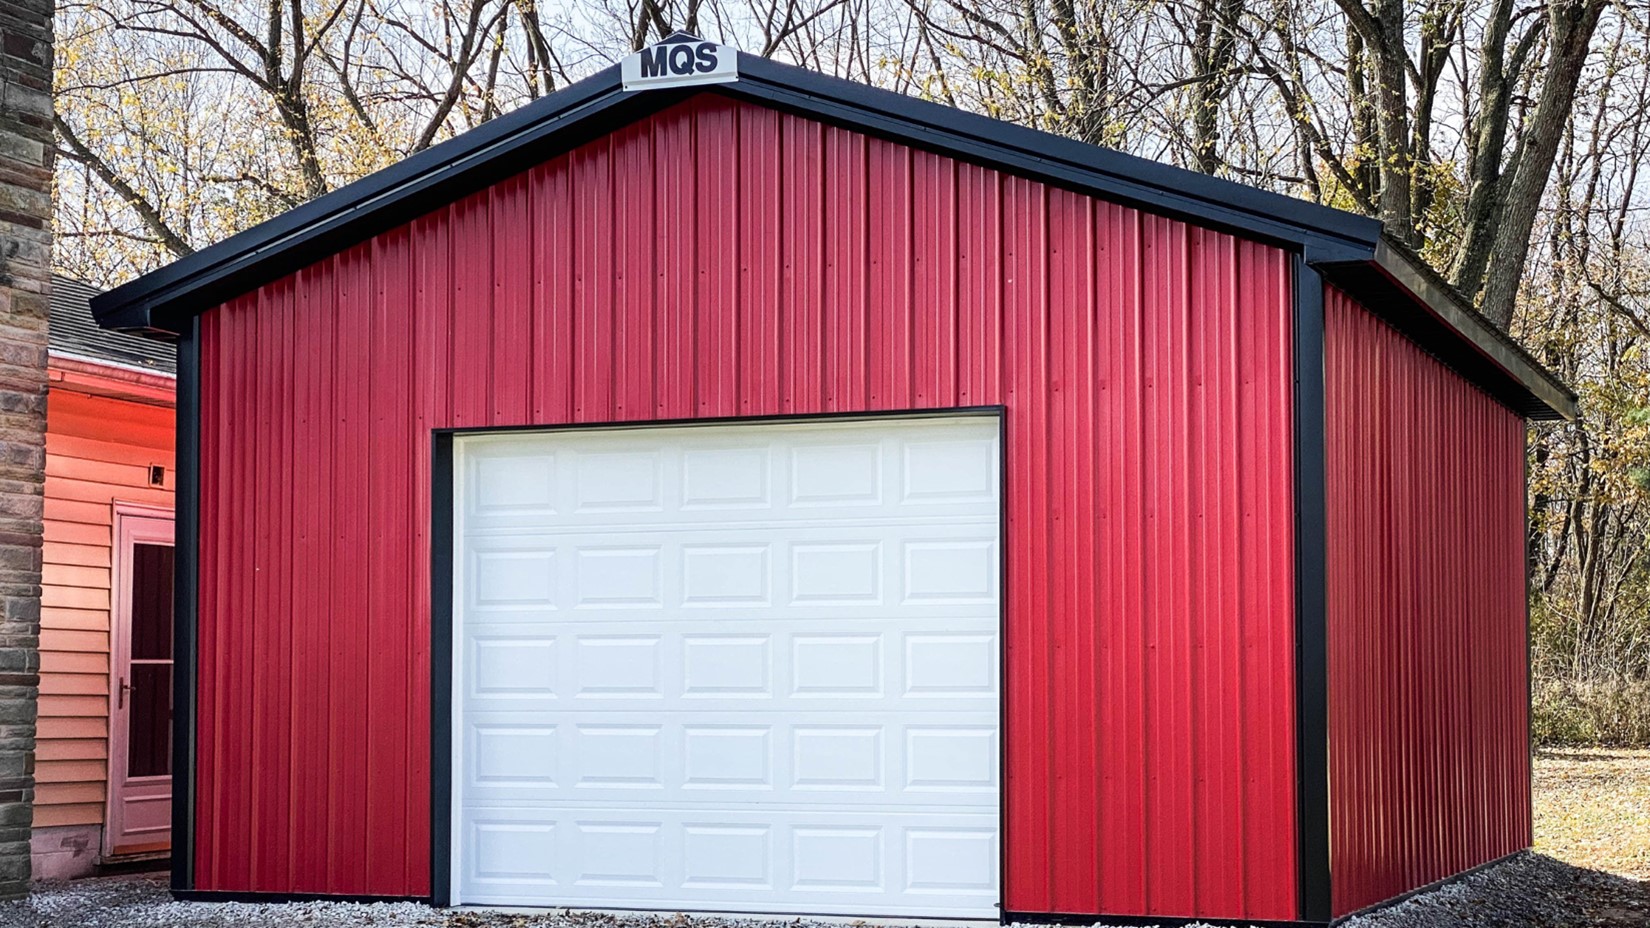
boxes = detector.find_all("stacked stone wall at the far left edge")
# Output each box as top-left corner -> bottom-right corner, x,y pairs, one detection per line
0,0 -> 53,898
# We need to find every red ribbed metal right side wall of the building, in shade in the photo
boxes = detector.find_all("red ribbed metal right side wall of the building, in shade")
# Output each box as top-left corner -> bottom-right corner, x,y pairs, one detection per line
1323,289 -> 1530,915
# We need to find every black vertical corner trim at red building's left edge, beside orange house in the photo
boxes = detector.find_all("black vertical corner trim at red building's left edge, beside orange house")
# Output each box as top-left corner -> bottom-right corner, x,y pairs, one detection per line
172,317 -> 201,892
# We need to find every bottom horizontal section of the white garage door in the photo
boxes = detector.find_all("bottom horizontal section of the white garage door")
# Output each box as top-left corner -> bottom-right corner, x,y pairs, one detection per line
464,806 -> 1000,916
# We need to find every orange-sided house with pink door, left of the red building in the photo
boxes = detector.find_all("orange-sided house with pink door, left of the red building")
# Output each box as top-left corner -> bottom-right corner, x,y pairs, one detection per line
33,277 -> 177,878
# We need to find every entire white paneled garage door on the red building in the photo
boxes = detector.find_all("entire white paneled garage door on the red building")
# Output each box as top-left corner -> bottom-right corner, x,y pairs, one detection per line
452,418 -> 1000,918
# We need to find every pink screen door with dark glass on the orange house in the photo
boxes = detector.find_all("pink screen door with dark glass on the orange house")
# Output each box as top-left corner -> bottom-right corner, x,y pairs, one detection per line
104,504 -> 173,857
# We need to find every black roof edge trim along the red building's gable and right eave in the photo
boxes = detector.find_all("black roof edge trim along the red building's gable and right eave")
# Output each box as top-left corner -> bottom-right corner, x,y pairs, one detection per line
92,42 -> 1574,418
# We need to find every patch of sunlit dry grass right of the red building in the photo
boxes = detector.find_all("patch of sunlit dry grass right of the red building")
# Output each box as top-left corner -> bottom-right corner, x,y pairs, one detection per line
1535,748 -> 1650,880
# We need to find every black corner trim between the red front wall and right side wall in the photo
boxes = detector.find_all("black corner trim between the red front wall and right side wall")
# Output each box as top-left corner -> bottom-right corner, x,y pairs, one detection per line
1295,258 -> 1332,923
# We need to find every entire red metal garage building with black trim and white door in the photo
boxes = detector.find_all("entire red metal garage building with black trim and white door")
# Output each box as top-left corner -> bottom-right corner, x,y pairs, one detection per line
96,40 -> 1574,923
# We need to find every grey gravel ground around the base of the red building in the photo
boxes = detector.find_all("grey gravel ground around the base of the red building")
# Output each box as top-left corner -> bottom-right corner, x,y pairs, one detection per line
0,854 -> 1650,928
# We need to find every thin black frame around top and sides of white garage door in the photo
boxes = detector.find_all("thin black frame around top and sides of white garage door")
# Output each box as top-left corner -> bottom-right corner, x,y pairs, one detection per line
429,405 -> 1008,920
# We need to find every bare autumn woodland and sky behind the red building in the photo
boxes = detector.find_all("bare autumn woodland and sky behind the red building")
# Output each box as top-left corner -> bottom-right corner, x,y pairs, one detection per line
56,0 -> 1650,738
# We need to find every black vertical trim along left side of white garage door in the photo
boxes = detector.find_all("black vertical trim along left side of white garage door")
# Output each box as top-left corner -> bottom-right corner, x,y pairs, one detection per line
429,431 -> 454,907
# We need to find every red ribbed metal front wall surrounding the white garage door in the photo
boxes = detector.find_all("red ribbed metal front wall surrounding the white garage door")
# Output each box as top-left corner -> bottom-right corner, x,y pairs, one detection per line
196,96 -> 1295,918
